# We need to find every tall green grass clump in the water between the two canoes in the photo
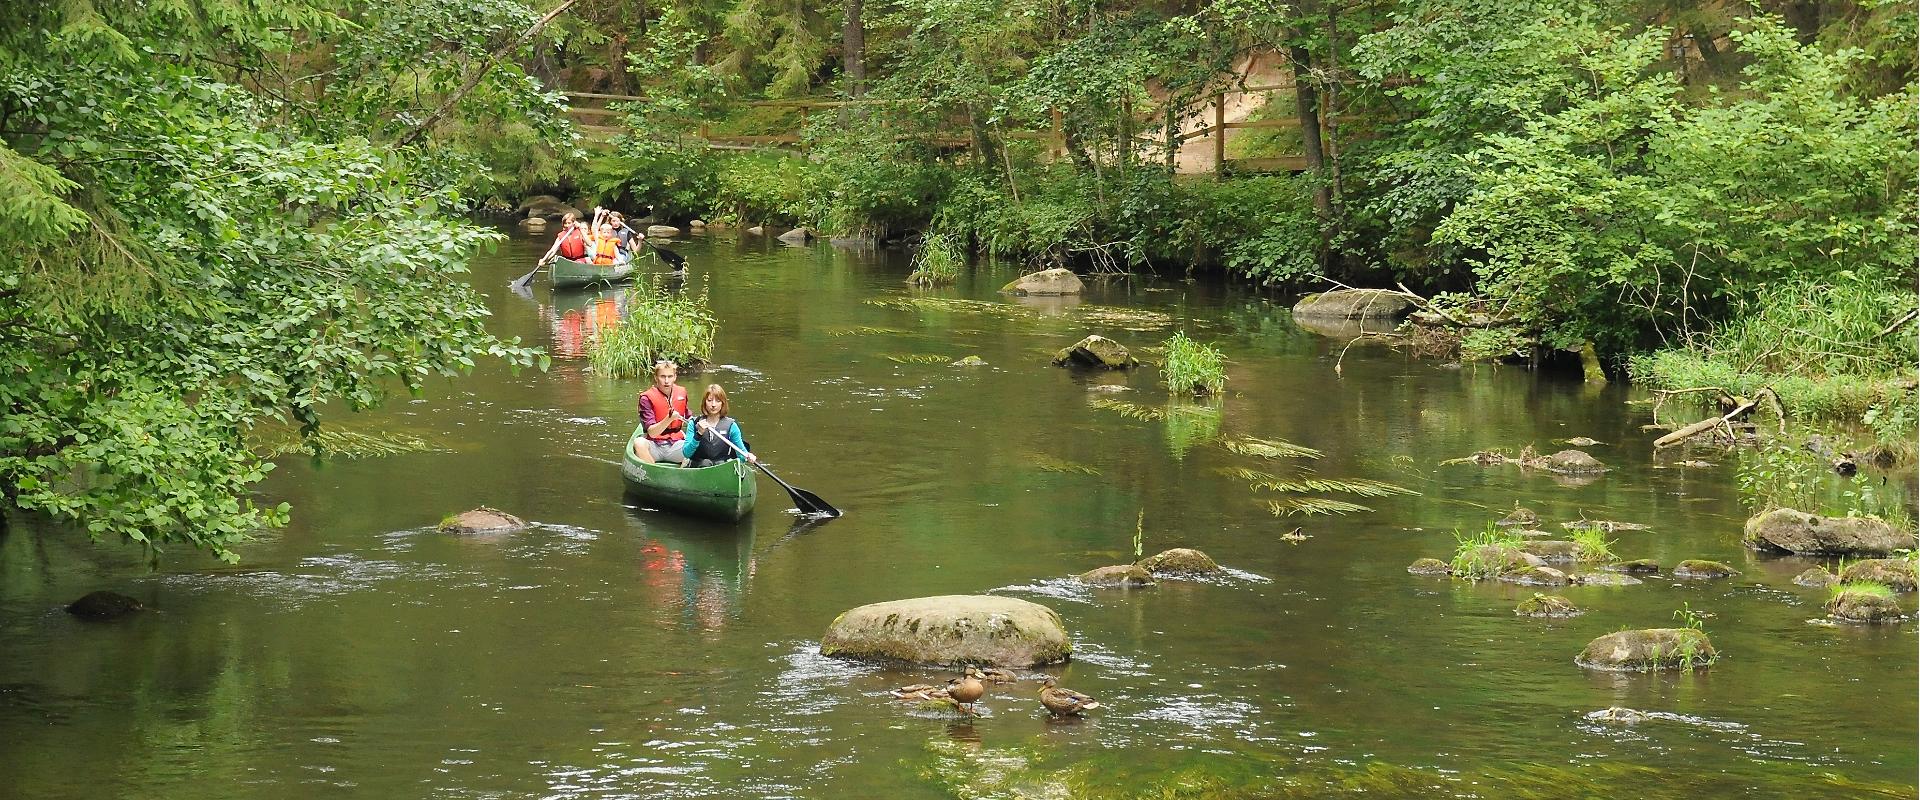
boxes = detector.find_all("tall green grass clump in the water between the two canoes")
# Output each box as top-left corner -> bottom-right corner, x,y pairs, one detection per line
588,286 -> 714,378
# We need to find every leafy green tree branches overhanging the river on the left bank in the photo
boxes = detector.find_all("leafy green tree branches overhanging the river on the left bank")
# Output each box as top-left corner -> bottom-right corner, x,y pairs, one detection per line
0,0 -> 549,560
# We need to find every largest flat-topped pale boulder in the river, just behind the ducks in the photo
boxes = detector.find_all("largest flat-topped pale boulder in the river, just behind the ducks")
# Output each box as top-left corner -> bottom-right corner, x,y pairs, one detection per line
820,595 -> 1073,668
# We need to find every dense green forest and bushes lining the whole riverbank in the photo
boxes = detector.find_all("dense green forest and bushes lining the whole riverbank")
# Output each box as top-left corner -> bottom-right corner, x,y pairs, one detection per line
0,0 -> 1920,556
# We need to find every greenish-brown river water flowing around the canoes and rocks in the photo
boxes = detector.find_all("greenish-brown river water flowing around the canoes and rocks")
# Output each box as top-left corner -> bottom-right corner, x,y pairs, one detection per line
0,227 -> 1920,798
